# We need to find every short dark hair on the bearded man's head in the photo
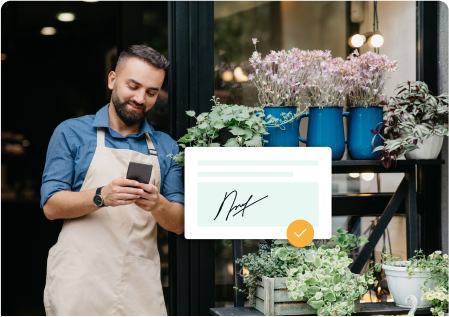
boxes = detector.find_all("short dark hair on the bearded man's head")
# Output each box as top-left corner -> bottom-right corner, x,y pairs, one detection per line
116,45 -> 170,72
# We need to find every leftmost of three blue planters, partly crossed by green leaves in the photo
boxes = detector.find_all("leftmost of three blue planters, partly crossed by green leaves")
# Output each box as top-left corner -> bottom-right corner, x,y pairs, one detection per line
263,107 -> 299,147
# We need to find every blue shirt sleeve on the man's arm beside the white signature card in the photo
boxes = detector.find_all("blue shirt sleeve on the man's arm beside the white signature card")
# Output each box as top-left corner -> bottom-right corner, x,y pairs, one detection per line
162,141 -> 184,205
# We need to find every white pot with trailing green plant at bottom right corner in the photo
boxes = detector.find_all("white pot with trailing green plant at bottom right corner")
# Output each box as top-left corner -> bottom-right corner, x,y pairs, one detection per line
373,250 -> 449,308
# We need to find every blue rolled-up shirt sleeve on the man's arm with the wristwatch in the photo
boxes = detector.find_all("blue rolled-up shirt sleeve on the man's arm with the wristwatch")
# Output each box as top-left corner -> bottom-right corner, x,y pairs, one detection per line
41,122 -> 75,208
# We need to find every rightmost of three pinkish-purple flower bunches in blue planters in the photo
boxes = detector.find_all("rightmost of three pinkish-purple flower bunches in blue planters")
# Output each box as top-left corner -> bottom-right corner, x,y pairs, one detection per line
345,50 -> 398,107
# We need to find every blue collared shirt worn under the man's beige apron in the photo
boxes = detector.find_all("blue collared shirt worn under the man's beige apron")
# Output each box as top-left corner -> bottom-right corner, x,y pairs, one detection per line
41,104 -> 184,208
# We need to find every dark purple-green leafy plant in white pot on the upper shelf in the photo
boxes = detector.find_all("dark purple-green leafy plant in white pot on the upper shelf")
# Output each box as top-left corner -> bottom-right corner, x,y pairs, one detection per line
373,81 -> 449,168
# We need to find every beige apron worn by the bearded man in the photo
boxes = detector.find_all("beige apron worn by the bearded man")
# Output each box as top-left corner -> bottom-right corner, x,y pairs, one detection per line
44,128 -> 167,316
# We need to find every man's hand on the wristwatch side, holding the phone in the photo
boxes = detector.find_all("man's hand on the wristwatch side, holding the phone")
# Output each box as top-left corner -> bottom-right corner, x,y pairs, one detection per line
101,176 -> 144,207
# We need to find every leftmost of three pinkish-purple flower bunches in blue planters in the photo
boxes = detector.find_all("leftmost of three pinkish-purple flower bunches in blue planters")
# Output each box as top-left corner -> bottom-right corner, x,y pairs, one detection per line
248,38 -> 304,107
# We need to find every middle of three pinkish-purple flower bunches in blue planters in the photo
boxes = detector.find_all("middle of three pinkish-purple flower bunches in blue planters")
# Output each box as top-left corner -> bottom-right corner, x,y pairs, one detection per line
290,48 -> 351,108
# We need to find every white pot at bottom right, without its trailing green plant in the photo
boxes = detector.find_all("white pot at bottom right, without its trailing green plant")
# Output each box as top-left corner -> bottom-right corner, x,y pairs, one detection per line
382,261 -> 434,308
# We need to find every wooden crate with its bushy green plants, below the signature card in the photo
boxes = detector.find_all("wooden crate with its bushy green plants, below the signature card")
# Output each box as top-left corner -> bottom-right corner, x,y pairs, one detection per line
236,228 -> 375,316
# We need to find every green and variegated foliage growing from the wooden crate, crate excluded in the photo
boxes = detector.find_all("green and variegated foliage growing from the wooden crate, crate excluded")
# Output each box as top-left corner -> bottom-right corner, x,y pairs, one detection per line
236,228 -> 375,316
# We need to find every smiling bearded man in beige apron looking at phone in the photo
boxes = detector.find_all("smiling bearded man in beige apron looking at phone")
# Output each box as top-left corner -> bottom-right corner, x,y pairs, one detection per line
41,45 -> 184,315
